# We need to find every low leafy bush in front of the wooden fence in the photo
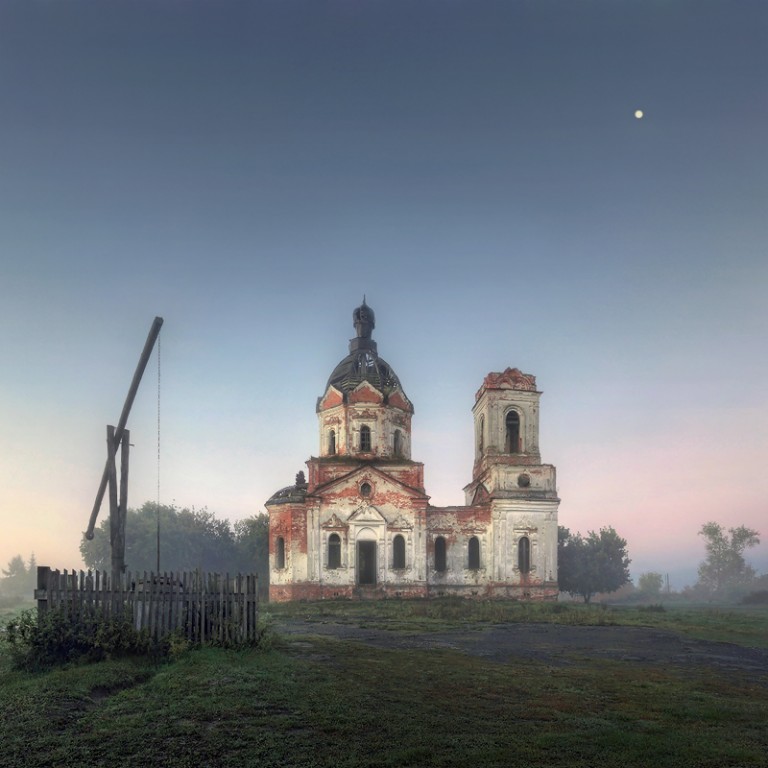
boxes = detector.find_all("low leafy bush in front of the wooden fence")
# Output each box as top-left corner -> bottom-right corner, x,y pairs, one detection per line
5,608 -> 166,669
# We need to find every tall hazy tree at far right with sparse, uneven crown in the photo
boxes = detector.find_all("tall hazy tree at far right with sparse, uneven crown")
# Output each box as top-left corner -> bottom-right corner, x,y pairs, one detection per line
696,522 -> 760,597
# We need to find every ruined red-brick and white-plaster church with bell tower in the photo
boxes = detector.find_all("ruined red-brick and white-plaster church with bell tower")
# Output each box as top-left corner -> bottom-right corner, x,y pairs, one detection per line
266,300 -> 560,601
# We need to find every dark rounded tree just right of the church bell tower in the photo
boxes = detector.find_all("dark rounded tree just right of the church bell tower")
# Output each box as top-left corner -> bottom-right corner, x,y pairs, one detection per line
557,526 -> 631,603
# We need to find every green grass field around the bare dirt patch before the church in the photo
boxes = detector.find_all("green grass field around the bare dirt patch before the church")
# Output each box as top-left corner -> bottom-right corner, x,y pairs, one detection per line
0,601 -> 768,768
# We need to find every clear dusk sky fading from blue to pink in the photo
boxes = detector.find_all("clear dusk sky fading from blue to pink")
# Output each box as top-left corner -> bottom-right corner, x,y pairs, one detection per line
0,0 -> 768,588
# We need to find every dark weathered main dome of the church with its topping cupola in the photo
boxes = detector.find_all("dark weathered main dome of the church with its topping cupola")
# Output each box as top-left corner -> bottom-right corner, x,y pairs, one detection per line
325,298 -> 403,395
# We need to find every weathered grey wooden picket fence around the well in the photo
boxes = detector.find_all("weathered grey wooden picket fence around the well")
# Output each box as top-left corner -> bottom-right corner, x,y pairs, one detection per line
35,566 -> 259,645
